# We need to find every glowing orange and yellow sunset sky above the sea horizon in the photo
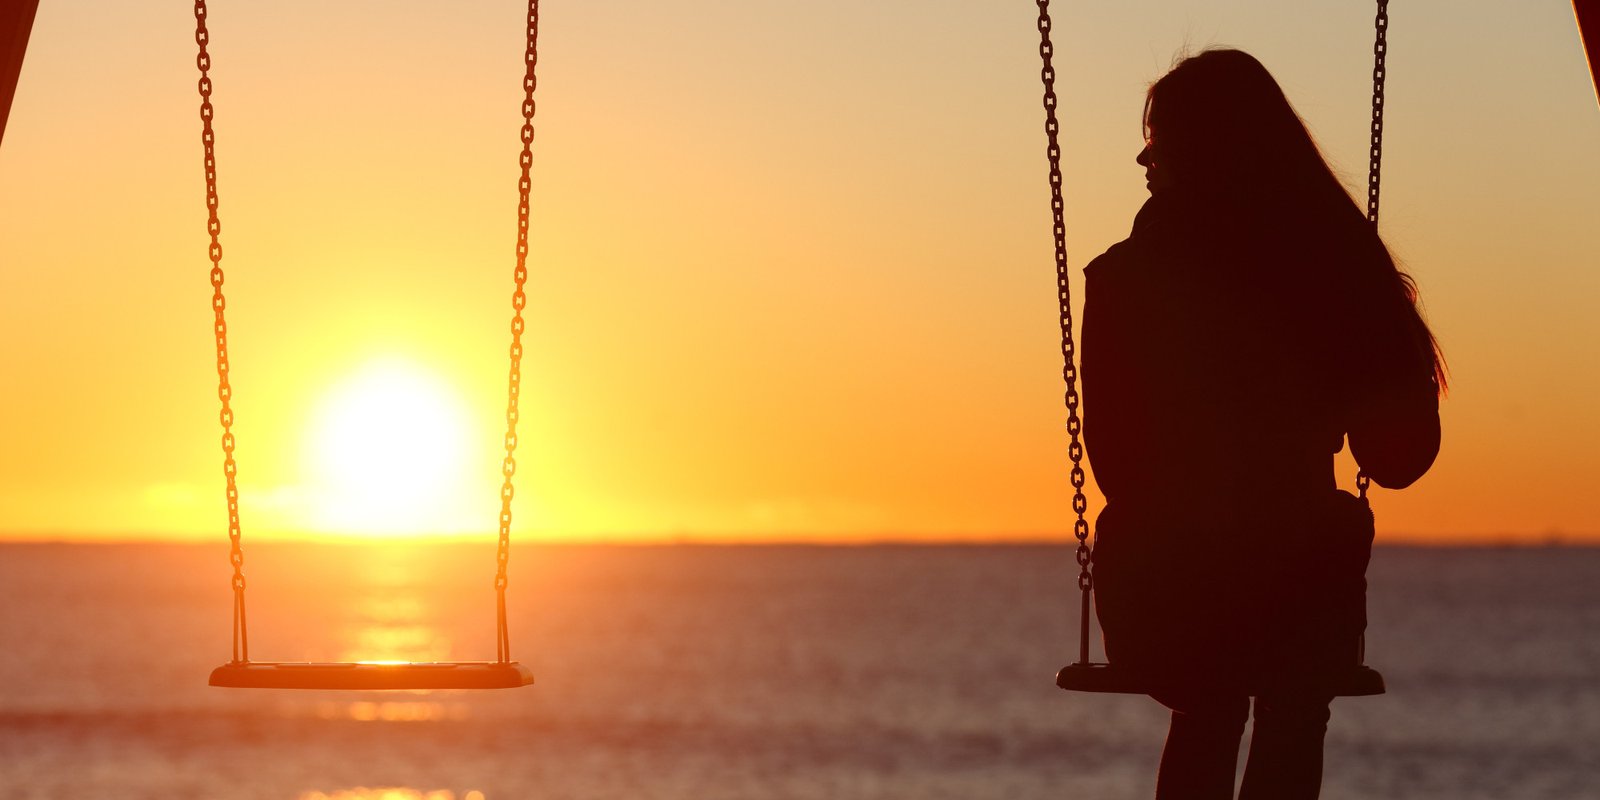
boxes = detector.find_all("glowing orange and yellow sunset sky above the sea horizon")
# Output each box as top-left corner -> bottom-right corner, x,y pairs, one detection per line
0,0 -> 1600,541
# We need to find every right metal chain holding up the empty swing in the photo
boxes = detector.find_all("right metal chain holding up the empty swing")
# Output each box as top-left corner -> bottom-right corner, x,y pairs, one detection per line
494,0 -> 539,662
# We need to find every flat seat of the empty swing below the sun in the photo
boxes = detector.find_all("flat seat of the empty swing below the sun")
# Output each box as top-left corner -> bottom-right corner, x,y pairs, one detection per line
211,661 -> 533,690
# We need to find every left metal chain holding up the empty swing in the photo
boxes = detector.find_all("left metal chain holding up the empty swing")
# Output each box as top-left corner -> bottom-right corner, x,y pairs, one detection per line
195,0 -> 250,662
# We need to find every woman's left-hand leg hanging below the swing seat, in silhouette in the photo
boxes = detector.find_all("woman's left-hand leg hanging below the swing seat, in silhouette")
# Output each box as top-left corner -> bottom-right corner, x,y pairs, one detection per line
1155,693 -> 1250,800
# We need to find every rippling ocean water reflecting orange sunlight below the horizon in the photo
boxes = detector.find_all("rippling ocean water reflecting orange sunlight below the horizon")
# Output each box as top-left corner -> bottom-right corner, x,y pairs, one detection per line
0,542 -> 1600,800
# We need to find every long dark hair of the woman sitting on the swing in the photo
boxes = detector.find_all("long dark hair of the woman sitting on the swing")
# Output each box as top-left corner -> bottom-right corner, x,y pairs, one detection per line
1144,48 -> 1446,390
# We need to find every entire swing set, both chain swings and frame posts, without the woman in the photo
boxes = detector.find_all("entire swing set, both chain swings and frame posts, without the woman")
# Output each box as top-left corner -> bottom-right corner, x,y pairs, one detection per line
0,0 -> 1600,696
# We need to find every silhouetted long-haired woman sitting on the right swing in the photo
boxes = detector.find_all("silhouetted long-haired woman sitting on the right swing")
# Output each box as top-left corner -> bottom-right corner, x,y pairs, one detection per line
1083,50 -> 1445,800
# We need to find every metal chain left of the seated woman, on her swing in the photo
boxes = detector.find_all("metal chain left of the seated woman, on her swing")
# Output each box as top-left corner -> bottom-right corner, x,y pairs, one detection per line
1037,0 -> 1094,662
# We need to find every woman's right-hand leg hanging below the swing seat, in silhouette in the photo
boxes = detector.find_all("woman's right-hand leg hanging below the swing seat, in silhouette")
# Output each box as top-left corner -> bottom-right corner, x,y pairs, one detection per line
1238,694 -> 1333,800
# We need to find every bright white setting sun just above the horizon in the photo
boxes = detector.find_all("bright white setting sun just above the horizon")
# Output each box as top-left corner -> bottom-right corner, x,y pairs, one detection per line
307,358 -> 494,536
